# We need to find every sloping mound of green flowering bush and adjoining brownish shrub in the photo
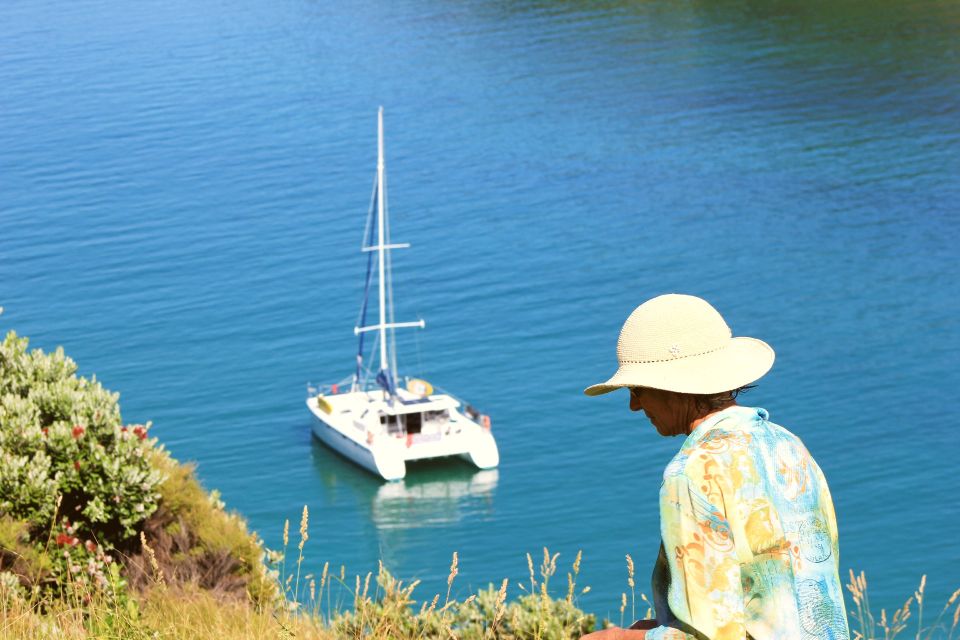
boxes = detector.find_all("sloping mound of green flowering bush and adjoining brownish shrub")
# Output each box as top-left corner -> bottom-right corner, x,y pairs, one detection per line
0,332 -> 277,606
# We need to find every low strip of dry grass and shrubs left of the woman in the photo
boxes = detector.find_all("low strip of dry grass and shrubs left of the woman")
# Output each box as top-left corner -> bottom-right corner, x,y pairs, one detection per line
0,536 -> 596,640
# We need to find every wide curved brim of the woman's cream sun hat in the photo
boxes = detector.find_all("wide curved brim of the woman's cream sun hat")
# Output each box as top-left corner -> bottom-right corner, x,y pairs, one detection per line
584,338 -> 775,396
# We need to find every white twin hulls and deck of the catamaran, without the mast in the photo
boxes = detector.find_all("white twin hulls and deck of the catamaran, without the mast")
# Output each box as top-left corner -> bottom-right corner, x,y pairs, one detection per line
307,391 -> 500,480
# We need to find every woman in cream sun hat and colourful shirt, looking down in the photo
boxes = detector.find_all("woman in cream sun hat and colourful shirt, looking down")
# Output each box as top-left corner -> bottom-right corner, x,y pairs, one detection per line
586,294 -> 849,640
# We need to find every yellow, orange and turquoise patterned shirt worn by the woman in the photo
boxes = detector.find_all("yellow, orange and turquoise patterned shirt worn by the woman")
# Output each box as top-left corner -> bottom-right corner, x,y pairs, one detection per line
646,406 -> 850,640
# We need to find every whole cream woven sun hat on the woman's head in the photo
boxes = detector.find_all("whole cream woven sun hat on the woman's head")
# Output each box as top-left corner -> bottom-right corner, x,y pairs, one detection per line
584,293 -> 774,396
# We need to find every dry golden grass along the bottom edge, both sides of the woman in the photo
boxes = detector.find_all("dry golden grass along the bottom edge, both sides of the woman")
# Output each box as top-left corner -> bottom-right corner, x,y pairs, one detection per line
0,509 -> 960,640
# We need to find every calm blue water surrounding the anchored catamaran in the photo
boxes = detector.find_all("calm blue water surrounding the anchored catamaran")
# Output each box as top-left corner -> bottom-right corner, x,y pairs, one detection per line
0,0 -> 960,619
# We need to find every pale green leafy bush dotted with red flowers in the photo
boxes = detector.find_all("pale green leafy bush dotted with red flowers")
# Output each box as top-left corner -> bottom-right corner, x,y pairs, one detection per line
0,332 -> 162,583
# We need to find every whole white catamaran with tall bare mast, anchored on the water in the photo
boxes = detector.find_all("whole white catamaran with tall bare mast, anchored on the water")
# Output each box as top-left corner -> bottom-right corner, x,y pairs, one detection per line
307,107 -> 500,480
